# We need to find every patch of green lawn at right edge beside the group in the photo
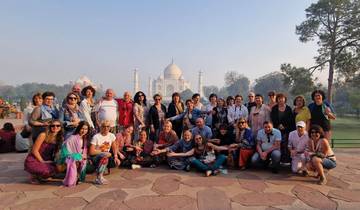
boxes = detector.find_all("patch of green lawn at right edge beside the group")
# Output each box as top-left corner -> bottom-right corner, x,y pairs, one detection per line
331,118 -> 360,147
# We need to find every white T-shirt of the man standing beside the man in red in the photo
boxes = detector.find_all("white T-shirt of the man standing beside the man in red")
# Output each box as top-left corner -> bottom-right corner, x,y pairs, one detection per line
95,99 -> 117,127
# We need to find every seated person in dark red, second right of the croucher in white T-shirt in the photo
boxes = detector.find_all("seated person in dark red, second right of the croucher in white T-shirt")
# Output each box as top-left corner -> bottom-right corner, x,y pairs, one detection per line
129,130 -> 155,169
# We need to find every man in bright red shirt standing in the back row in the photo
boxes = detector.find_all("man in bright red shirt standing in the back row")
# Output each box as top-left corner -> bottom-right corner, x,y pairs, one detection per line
115,91 -> 134,132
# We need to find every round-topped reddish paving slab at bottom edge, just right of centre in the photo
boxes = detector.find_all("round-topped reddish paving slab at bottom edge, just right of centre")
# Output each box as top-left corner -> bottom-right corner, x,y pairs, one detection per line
197,188 -> 231,210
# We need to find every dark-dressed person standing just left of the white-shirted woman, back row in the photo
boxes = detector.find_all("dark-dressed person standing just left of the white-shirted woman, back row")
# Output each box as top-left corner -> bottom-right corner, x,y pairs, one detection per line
211,98 -> 228,133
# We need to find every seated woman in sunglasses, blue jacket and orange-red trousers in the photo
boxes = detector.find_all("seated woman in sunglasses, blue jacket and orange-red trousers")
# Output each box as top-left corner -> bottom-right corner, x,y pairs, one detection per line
229,118 -> 255,170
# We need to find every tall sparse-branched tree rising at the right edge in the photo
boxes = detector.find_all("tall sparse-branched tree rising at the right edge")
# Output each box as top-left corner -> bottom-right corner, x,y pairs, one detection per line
296,0 -> 360,102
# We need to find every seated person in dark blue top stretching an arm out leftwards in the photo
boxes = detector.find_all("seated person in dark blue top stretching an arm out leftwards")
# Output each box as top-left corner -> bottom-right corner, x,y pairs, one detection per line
153,130 -> 194,171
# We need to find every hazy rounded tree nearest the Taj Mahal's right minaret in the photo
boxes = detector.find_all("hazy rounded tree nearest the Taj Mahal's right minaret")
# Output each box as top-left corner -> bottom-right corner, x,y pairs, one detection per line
224,71 -> 250,96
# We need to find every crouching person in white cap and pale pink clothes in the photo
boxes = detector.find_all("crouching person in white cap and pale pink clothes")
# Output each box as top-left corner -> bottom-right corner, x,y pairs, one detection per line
288,121 -> 309,173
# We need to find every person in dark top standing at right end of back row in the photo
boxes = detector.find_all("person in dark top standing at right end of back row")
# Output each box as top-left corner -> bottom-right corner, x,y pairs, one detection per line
308,90 -> 336,142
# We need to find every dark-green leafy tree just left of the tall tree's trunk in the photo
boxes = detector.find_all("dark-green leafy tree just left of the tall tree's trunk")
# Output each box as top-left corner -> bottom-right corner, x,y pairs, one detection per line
280,63 -> 315,96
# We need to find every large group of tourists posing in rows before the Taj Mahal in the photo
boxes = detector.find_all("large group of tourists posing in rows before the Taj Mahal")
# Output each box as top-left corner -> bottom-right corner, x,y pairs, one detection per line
0,85 -> 336,186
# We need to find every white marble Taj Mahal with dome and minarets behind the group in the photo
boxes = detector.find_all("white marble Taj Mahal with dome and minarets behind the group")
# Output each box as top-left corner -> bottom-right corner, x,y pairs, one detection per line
134,60 -> 203,101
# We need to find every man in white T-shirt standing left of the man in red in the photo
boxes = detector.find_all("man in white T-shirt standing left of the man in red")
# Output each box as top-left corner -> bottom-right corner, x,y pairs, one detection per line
95,89 -> 117,133
